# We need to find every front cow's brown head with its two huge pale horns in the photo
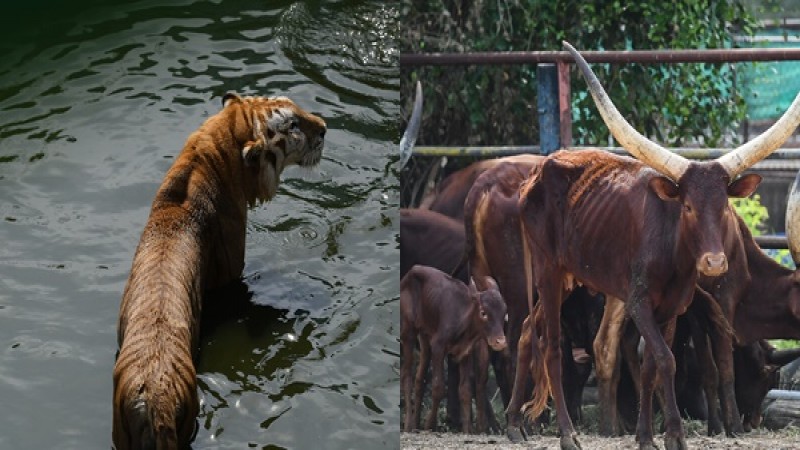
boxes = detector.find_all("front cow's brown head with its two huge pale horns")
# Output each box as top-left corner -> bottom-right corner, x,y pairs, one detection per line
564,42 -> 800,276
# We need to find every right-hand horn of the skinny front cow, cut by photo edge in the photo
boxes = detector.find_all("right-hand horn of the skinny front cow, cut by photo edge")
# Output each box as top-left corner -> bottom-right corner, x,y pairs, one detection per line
717,93 -> 800,180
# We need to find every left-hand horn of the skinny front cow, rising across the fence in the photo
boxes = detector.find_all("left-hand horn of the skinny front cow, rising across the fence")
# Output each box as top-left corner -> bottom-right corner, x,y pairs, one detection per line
562,41 -> 689,183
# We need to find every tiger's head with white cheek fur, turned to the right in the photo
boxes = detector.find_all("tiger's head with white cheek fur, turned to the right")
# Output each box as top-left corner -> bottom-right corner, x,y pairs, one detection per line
222,93 -> 326,206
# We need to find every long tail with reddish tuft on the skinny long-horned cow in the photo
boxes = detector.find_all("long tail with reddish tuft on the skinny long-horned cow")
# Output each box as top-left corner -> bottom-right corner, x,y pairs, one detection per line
520,218 -> 550,421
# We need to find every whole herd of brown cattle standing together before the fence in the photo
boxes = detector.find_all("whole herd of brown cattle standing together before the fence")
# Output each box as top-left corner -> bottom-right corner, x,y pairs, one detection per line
400,43 -> 800,449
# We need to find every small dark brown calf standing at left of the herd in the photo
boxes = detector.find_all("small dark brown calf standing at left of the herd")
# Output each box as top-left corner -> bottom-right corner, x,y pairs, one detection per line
400,266 -> 506,433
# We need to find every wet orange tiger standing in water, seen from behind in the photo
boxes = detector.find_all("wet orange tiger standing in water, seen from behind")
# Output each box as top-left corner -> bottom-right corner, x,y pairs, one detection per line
112,93 -> 326,450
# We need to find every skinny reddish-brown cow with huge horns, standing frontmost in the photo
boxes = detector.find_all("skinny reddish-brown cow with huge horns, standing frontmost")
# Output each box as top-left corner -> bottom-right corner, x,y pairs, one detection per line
520,43 -> 800,450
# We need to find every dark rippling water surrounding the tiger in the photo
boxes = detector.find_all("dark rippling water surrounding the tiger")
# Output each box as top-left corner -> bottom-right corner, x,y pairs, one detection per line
0,1 -> 400,449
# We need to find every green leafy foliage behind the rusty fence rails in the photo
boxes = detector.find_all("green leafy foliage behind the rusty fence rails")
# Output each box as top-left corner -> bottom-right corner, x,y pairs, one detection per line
401,0 -> 755,146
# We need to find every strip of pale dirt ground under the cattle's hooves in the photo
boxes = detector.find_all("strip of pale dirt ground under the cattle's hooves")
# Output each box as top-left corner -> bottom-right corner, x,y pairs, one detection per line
400,427 -> 800,450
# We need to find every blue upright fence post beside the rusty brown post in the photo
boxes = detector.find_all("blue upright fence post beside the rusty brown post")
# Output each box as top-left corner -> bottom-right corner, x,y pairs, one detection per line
536,64 -> 561,155
